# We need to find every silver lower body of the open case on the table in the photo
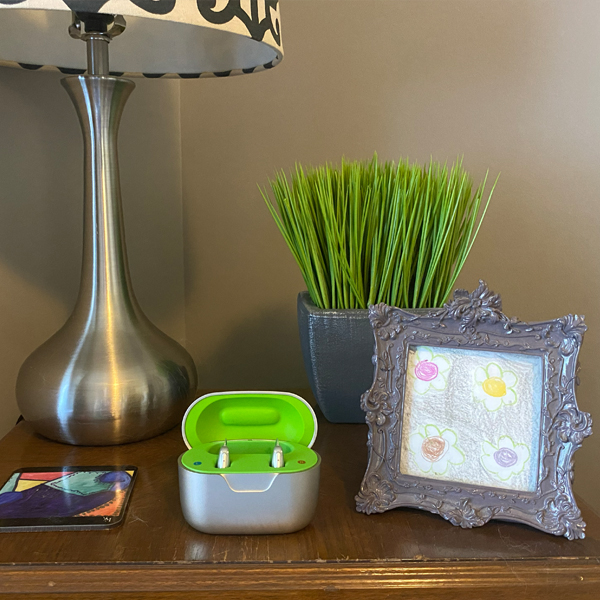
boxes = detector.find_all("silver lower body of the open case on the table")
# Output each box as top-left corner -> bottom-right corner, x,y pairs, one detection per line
179,454 -> 321,535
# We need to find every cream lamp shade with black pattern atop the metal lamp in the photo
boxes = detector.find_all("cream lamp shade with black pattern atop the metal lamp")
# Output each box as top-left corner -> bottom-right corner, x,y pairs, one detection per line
0,0 -> 283,78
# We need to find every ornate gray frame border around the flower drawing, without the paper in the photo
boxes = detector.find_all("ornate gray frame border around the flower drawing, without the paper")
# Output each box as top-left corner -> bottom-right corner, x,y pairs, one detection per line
356,281 -> 592,540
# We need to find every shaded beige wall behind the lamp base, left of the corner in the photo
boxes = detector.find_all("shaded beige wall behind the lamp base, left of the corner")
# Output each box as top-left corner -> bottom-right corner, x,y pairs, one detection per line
0,69 -> 185,437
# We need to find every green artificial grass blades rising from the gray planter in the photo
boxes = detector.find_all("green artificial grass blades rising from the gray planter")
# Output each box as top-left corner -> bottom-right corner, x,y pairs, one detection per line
261,154 -> 495,308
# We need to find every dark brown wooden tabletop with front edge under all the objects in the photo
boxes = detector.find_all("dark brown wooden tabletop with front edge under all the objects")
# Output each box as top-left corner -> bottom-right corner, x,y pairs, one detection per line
0,394 -> 600,600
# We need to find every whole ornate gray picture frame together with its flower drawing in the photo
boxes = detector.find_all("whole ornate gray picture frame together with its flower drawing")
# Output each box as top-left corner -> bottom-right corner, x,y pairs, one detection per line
356,281 -> 592,539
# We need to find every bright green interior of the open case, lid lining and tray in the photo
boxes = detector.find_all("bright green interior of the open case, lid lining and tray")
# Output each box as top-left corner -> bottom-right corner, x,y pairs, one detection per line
181,392 -> 318,474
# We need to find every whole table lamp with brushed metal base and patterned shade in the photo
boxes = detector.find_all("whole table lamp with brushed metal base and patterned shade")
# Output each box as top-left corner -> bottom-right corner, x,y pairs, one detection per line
0,0 -> 283,445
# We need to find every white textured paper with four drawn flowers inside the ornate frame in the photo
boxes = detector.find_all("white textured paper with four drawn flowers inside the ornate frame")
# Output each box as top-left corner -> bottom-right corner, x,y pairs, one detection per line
400,346 -> 542,492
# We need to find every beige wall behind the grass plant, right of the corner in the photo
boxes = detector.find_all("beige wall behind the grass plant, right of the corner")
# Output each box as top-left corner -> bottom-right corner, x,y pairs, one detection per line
181,0 -> 600,507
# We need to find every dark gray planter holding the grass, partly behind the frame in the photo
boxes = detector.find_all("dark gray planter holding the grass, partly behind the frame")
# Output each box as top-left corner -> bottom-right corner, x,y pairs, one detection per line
298,292 -> 374,423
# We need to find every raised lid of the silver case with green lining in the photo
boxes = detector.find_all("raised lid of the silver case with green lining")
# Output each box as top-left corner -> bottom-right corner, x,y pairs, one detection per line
181,392 -> 317,448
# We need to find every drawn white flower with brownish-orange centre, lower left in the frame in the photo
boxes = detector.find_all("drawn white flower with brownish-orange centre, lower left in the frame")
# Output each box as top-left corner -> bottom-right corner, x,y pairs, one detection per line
409,424 -> 465,475
